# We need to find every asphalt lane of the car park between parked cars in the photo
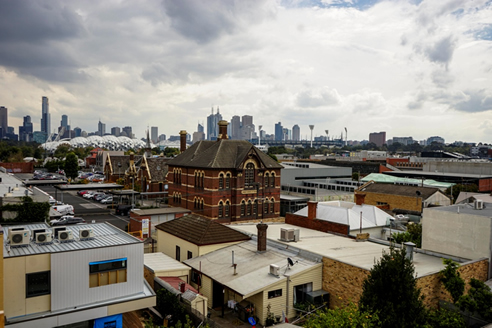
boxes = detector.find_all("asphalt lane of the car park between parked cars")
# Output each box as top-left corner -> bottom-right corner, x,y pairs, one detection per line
38,186 -> 130,230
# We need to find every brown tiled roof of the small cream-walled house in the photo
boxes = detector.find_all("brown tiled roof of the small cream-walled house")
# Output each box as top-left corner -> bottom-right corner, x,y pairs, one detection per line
156,214 -> 250,246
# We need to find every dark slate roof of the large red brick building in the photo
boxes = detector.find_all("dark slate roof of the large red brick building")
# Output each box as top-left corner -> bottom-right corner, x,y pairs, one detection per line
168,139 -> 282,169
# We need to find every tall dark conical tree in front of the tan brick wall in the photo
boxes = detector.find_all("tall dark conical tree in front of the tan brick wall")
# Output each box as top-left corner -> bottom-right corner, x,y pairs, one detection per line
360,247 -> 426,328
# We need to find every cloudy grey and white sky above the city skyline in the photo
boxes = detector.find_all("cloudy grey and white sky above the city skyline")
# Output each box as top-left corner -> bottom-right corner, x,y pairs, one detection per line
0,0 -> 492,143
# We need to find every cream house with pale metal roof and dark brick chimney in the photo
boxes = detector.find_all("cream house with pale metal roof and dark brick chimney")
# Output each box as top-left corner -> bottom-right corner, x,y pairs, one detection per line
184,223 -> 322,325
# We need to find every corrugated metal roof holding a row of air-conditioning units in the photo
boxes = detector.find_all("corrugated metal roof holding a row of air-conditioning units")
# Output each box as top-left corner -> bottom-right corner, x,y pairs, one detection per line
3,223 -> 142,258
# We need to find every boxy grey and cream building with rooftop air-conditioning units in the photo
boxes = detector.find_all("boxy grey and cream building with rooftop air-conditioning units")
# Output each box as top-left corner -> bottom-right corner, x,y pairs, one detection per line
3,223 -> 156,328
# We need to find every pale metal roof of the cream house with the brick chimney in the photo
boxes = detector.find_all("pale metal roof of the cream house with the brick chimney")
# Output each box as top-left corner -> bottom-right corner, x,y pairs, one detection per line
184,240 -> 321,298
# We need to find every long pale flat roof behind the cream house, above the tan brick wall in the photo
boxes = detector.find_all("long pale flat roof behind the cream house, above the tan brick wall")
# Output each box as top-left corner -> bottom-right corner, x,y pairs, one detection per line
230,223 -> 450,277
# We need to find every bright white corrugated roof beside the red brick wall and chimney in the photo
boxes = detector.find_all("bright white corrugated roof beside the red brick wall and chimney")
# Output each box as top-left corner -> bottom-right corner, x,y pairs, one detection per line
295,201 -> 391,230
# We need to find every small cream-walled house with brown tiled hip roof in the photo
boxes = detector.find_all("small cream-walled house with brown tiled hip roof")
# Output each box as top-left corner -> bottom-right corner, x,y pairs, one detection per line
156,214 -> 250,262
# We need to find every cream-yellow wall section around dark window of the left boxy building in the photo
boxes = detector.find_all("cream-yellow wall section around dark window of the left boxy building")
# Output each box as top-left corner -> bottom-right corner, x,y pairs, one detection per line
3,254 -> 51,318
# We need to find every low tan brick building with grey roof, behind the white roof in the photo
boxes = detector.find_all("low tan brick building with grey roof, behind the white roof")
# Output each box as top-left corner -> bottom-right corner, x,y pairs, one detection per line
355,181 -> 451,213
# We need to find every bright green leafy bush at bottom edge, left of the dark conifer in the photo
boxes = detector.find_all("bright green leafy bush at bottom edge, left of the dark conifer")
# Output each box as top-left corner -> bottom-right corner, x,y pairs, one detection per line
303,302 -> 380,328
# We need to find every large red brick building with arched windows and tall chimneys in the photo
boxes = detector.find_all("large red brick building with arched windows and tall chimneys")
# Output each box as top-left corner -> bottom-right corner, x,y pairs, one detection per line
167,121 -> 282,222
